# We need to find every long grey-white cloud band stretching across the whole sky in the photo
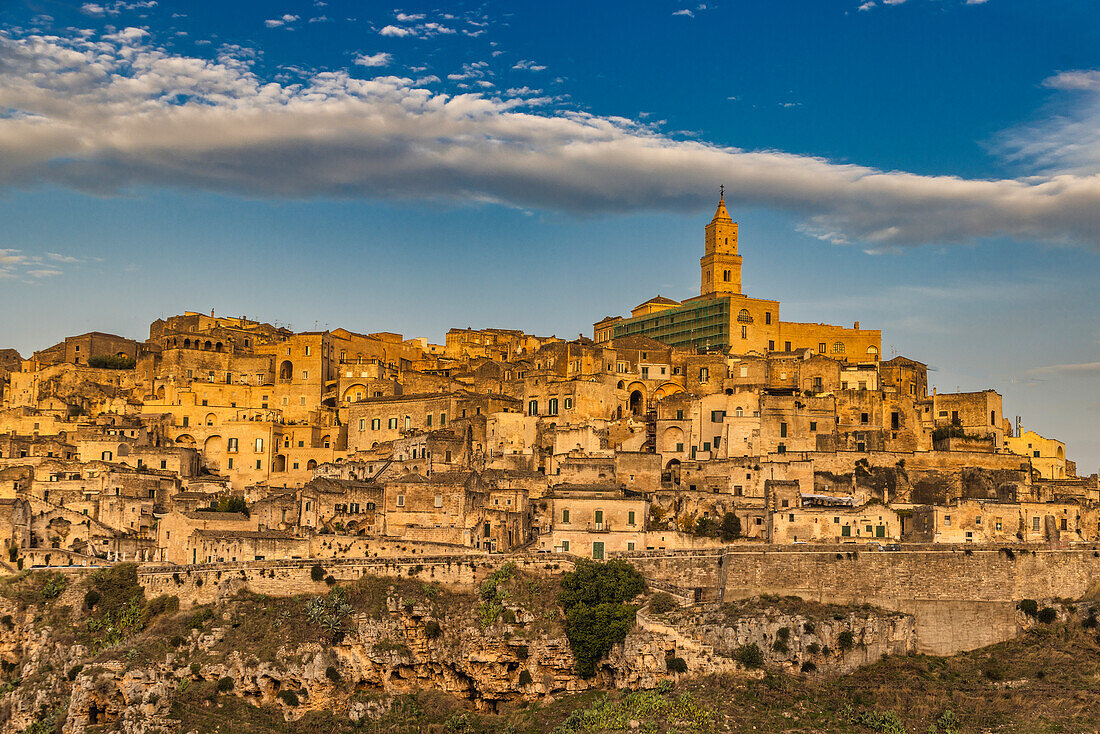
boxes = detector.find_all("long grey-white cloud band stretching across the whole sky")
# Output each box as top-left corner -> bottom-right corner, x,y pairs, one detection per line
0,29 -> 1100,253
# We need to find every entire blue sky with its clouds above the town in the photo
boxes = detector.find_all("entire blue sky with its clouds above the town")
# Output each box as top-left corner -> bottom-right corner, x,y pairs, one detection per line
0,0 -> 1100,472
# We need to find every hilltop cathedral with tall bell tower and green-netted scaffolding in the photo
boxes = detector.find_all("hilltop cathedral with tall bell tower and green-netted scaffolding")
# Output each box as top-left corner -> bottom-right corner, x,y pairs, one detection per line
593,197 -> 882,362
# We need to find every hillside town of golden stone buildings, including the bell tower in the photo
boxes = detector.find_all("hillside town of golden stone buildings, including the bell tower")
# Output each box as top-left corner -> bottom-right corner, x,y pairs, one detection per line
0,200 -> 1100,570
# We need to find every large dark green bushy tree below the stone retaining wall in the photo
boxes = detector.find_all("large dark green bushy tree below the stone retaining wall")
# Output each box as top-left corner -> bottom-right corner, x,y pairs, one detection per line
558,558 -> 646,678
